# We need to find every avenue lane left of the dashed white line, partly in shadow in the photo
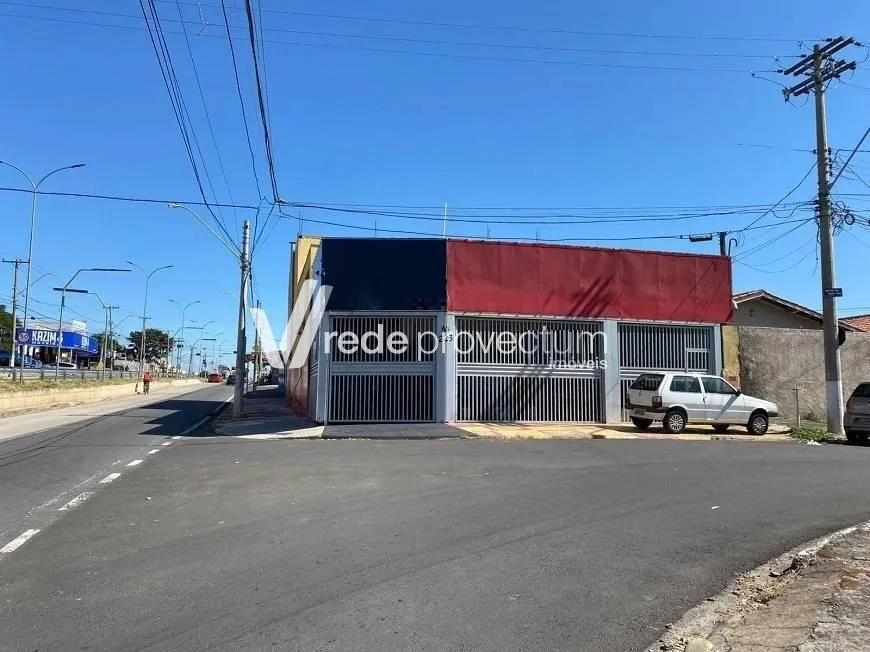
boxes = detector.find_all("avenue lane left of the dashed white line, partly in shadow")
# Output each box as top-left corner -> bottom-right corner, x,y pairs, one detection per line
0,385 -> 232,546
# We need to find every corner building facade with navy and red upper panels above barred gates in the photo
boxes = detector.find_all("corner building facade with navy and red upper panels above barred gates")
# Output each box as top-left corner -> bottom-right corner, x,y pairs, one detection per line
286,238 -> 732,423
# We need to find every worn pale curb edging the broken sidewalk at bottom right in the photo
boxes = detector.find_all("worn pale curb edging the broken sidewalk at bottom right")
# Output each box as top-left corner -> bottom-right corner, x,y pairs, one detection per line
646,521 -> 870,652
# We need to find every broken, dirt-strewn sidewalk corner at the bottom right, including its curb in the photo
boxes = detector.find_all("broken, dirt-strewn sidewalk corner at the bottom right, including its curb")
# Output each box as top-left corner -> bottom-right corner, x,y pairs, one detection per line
650,524 -> 870,652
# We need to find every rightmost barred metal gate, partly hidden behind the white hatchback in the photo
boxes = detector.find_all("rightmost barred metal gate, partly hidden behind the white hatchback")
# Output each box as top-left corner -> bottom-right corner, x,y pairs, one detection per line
618,323 -> 716,420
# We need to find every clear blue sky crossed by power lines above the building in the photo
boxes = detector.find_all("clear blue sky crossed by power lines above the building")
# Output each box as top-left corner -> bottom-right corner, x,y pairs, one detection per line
0,0 -> 870,350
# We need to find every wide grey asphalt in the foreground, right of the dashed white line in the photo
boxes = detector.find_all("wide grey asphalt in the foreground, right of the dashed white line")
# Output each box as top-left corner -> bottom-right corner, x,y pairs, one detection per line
0,439 -> 870,652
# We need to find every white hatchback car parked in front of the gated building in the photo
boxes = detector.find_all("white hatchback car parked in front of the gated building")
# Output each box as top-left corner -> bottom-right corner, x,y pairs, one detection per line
625,371 -> 779,435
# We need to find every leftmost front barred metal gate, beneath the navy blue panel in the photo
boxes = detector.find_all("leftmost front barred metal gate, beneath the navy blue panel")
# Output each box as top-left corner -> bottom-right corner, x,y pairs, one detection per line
321,314 -> 437,423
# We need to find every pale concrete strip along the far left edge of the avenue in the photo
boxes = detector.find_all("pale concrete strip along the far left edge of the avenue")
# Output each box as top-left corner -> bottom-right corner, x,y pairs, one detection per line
0,381 -> 207,441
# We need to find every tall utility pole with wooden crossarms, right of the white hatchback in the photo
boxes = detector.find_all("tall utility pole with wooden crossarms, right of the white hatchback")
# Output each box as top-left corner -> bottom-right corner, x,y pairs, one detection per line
781,36 -> 857,435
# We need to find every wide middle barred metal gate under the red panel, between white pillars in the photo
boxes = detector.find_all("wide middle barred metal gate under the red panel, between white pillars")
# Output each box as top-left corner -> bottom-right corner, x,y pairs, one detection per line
455,317 -> 604,422
